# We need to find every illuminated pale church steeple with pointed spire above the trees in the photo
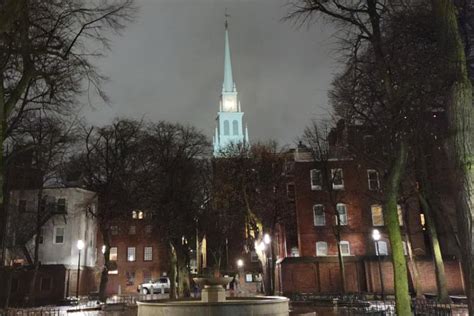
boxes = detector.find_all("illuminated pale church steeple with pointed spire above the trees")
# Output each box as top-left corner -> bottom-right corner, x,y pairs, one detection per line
213,20 -> 249,157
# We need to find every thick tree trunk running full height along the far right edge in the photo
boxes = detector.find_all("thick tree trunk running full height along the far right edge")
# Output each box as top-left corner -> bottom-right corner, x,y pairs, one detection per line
432,0 -> 474,315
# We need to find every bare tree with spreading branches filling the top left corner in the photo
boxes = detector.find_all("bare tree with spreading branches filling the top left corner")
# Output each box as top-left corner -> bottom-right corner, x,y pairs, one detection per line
0,0 -> 135,265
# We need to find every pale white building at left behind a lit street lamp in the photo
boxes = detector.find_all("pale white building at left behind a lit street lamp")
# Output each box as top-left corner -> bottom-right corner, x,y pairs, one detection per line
8,188 -> 97,269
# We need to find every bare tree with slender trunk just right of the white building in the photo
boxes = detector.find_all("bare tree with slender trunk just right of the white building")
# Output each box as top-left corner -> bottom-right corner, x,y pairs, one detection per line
75,120 -> 142,301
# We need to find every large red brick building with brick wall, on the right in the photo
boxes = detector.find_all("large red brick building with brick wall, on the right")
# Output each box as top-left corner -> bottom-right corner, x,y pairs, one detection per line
276,121 -> 464,294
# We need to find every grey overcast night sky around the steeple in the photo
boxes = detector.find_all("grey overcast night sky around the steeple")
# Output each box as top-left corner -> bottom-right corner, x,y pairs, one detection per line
84,0 -> 337,144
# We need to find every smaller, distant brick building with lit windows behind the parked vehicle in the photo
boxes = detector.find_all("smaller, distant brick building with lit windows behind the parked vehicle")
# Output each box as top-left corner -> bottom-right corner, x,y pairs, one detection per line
97,210 -> 169,295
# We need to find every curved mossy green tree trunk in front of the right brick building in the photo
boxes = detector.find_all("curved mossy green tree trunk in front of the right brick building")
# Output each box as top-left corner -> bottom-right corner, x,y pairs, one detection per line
384,140 -> 411,315
